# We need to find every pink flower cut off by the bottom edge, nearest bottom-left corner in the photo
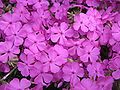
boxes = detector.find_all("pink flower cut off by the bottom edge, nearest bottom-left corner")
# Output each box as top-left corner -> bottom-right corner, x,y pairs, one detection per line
9,78 -> 31,90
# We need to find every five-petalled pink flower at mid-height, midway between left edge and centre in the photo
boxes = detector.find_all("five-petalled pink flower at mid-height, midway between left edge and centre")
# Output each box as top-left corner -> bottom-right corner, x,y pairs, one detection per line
24,33 -> 46,53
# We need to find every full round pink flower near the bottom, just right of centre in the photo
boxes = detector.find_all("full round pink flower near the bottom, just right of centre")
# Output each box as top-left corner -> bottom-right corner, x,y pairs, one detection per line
62,62 -> 84,85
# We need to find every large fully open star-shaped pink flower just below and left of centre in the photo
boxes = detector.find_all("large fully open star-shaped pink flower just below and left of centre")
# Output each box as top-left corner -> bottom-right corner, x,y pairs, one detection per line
41,49 -> 67,73
